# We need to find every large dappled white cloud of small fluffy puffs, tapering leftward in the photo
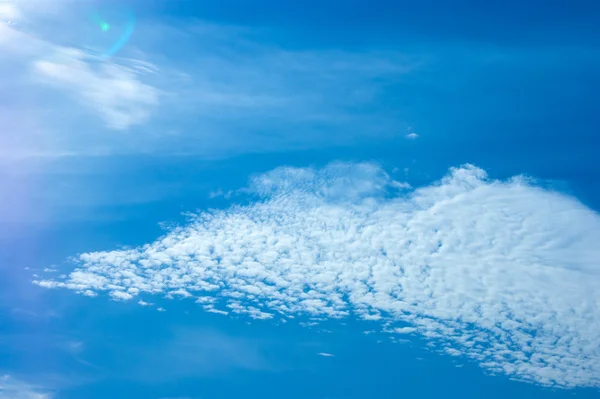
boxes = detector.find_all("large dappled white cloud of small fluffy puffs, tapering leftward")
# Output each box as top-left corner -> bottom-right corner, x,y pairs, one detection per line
37,163 -> 600,387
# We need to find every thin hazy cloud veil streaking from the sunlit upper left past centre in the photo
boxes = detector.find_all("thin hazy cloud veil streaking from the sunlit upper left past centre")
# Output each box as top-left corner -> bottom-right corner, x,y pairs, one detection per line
0,2 -> 420,160
